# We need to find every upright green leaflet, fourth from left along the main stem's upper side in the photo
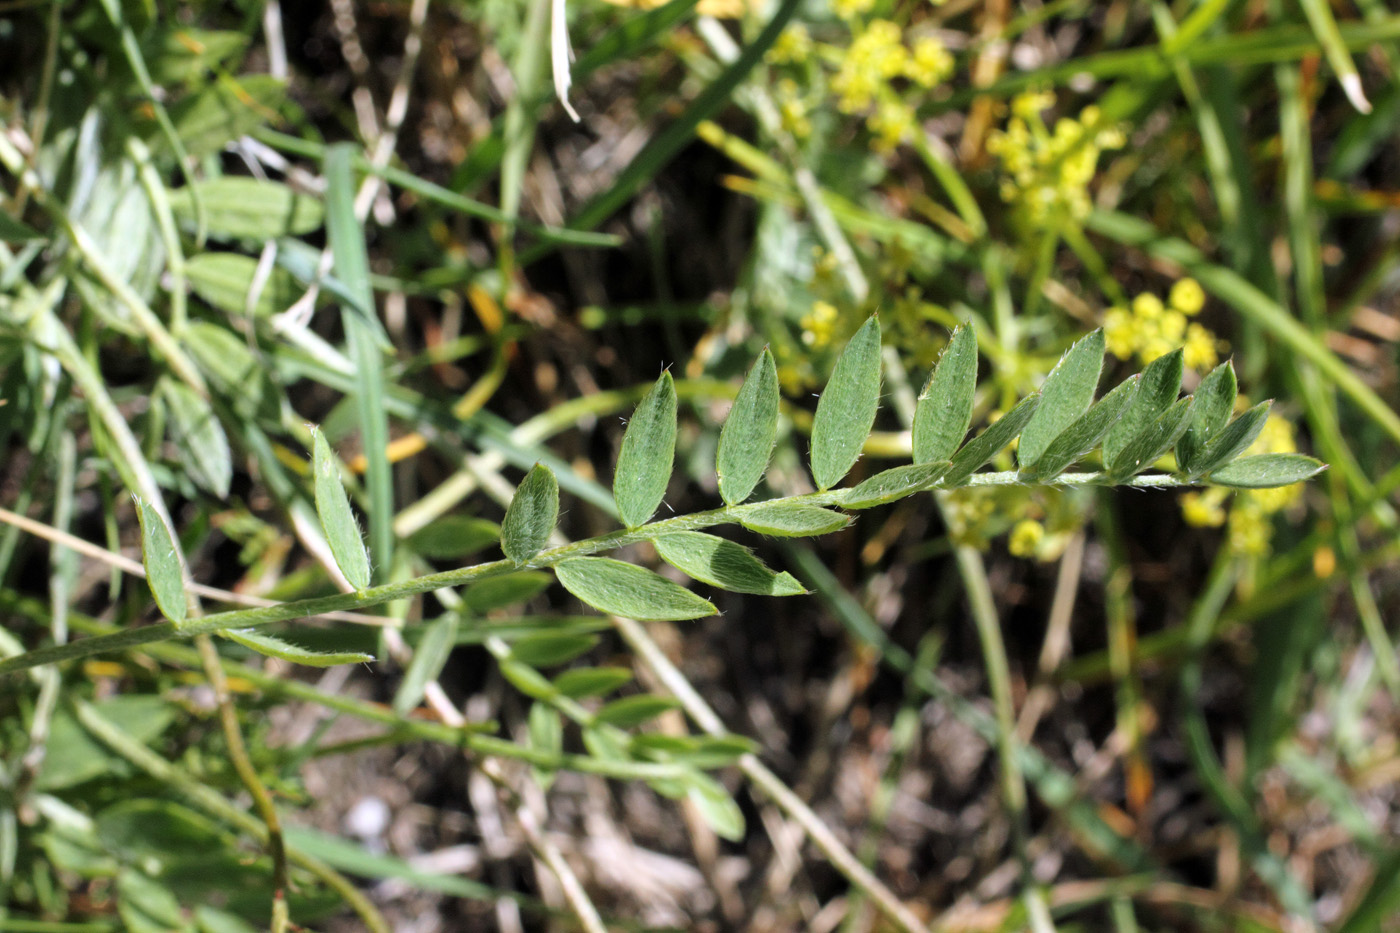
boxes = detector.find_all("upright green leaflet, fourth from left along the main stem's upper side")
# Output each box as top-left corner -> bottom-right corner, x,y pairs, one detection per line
613,373 -> 676,529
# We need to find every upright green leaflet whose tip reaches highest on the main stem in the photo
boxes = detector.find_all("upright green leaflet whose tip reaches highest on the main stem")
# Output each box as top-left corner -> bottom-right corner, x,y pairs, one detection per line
812,317 -> 881,490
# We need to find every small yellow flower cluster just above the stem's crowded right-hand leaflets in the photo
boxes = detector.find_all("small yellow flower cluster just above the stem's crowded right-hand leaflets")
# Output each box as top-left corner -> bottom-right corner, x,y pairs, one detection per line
1103,279 -> 1226,370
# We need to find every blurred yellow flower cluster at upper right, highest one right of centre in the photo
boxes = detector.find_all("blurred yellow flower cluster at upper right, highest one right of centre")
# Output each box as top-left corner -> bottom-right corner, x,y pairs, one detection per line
987,92 -> 1126,230
